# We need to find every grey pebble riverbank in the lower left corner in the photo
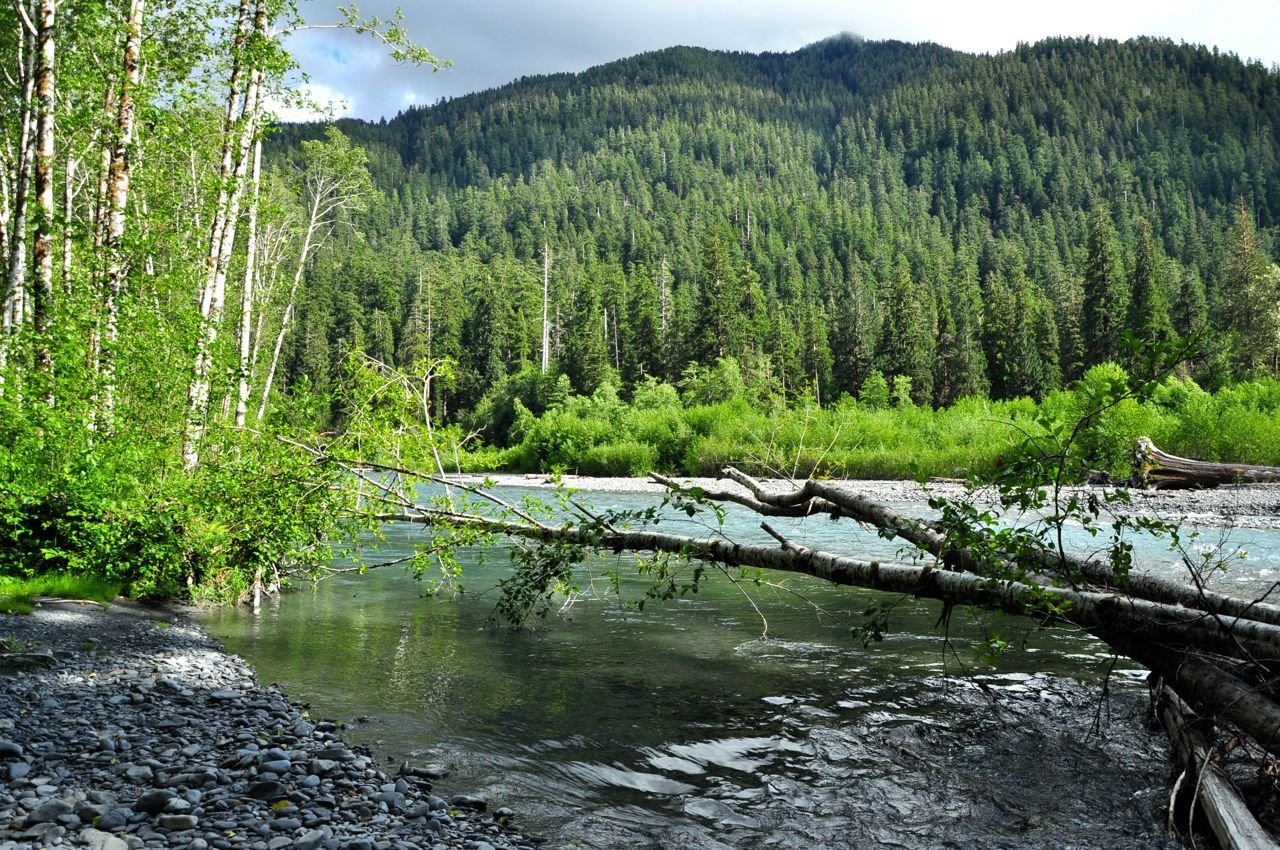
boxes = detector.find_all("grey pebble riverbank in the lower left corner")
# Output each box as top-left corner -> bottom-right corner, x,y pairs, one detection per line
0,600 -> 536,850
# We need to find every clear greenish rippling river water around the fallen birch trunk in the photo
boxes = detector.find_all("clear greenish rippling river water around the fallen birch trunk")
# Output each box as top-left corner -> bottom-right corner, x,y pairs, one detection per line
206,483 -> 1280,849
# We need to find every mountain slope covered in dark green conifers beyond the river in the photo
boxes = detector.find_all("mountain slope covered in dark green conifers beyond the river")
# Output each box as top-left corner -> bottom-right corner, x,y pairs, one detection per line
268,37 -> 1280,427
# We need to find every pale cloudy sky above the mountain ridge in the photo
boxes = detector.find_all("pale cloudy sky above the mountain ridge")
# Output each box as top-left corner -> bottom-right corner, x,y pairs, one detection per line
278,0 -> 1280,120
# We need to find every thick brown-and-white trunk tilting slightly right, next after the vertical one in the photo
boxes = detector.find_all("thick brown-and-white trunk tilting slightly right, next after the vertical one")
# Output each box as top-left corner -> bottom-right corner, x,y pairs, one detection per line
99,0 -> 145,429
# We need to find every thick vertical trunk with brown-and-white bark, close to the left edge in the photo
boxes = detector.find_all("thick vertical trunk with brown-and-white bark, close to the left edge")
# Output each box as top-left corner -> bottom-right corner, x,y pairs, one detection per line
32,0 -> 58,381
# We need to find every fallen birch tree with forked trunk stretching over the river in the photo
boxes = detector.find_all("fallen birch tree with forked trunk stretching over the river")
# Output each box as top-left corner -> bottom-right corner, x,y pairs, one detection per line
314,455 -> 1280,847
